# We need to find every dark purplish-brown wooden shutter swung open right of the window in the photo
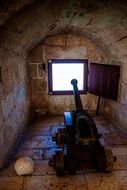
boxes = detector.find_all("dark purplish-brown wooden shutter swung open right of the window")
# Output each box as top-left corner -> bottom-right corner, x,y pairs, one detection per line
88,63 -> 120,100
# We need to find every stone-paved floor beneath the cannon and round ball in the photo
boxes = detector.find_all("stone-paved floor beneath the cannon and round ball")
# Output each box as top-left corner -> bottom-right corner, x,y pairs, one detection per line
0,117 -> 127,190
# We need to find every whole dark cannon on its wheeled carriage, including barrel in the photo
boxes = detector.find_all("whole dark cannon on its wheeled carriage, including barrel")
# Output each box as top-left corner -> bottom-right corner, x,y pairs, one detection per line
49,79 -> 116,176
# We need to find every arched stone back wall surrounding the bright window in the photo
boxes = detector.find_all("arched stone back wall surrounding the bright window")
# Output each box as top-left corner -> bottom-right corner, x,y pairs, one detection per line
28,34 -> 106,115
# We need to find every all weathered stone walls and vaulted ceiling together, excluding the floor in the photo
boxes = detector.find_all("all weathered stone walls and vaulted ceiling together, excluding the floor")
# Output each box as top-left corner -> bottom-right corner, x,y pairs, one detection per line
0,0 -> 127,167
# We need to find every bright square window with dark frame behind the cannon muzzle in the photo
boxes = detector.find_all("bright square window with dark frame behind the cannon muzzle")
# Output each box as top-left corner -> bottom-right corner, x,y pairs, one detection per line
48,59 -> 88,94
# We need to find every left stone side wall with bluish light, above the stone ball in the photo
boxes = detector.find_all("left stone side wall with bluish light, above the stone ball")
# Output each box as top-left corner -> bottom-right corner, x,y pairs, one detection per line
0,52 -> 29,167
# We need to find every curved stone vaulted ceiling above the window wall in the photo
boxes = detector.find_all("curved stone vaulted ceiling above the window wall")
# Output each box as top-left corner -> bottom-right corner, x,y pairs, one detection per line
0,0 -> 127,61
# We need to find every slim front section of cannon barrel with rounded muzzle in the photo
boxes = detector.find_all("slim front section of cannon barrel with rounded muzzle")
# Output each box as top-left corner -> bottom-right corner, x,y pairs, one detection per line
71,79 -> 83,111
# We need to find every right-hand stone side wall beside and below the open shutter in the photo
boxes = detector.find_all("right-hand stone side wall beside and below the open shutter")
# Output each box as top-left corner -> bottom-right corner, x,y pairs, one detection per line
104,57 -> 127,132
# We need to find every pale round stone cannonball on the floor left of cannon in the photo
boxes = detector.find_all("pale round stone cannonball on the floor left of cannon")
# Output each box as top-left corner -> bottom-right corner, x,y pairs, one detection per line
14,157 -> 34,175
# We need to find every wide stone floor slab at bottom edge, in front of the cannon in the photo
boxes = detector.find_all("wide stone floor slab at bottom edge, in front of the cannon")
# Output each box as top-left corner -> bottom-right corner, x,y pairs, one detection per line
24,175 -> 88,190
